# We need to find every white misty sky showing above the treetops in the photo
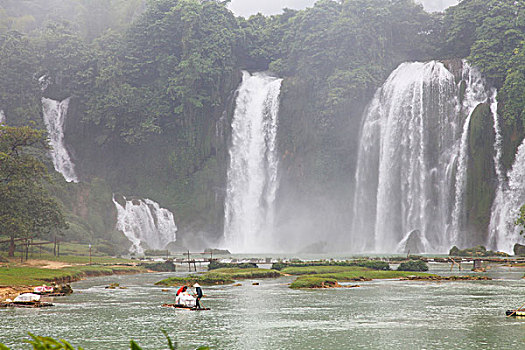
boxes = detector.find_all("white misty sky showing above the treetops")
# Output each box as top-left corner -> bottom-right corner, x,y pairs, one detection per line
229,0 -> 458,17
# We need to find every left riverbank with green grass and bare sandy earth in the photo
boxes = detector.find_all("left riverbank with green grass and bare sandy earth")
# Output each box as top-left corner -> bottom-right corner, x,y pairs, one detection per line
0,257 -> 148,301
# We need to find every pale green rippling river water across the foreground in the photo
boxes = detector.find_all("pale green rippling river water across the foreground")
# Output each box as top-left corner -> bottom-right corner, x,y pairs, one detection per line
0,265 -> 525,349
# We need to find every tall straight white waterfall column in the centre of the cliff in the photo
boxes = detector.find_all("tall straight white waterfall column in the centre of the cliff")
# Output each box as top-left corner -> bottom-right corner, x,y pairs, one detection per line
224,72 -> 282,252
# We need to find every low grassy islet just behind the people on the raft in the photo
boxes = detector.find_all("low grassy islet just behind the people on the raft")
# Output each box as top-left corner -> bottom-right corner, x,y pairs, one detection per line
155,268 -> 282,286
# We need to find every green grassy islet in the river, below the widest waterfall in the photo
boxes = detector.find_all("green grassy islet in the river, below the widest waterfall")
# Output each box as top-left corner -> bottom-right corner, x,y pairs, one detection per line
282,266 -> 429,289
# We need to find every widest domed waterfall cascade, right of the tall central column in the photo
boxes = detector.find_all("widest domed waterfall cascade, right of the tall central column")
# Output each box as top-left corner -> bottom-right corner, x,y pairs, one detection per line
351,61 -> 489,252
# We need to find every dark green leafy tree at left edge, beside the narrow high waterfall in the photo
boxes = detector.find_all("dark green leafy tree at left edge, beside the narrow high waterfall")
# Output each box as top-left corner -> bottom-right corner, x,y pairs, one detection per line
0,126 -> 67,257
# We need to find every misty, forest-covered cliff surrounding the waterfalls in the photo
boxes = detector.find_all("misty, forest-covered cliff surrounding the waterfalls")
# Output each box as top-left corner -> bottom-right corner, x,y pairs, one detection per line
0,0 -> 525,253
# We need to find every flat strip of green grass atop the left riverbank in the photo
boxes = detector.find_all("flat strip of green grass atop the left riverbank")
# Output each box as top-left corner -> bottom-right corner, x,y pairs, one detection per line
0,265 -> 145,286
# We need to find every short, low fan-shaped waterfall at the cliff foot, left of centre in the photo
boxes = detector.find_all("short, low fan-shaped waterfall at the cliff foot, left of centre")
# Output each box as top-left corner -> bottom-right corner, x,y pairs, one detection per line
113,196 -> 177,254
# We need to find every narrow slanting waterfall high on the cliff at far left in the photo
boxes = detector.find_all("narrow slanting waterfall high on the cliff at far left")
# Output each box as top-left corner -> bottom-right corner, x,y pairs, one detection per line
42,97 -> 78,182
